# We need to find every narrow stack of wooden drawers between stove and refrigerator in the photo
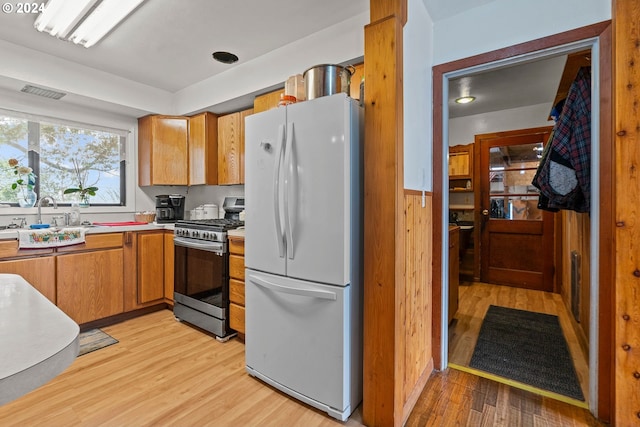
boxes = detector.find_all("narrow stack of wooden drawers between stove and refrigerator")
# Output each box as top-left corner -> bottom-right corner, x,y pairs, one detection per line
229,236 -> 245,337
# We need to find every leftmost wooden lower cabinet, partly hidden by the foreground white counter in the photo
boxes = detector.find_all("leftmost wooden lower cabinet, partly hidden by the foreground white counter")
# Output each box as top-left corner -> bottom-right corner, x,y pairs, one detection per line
0,251 -> 56,304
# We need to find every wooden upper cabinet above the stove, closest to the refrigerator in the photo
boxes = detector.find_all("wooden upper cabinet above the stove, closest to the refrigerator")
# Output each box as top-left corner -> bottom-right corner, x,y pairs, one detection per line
218,109 -> 253,185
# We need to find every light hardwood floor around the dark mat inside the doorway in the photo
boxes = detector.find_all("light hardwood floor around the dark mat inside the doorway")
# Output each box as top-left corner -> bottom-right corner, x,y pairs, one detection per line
449,282 -> 589,401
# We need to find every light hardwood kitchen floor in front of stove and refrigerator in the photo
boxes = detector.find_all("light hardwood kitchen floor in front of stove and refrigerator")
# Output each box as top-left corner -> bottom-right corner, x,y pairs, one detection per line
0,310 -> 362,427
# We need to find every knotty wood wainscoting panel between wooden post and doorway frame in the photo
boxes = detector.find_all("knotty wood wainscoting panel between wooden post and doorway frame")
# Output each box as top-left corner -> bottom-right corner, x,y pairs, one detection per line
401,191 -> 433,416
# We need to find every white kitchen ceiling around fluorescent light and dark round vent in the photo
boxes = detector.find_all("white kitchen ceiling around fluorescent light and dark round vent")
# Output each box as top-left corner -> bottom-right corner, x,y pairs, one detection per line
0,0 -> 369,92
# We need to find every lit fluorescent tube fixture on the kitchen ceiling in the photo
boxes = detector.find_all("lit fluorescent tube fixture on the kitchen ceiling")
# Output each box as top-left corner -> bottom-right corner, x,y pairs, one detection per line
34,0 -> 144,47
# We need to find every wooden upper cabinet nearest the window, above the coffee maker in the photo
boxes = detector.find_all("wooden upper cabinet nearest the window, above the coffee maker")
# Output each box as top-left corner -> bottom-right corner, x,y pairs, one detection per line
138,115 -> 189,186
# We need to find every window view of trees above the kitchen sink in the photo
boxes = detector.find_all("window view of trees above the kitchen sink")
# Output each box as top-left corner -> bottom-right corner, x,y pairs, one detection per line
0,115 -> 125,205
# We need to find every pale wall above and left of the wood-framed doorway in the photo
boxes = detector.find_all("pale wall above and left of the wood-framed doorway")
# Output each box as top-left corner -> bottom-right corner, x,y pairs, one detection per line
404,0 -> 611,189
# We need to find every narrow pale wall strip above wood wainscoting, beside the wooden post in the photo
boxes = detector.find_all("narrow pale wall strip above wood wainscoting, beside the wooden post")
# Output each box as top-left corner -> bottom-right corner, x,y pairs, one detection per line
404,0 -> 433,191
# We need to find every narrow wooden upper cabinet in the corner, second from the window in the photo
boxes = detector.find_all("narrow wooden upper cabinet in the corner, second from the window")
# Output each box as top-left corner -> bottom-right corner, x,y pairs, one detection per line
189,112 -> 218,185
